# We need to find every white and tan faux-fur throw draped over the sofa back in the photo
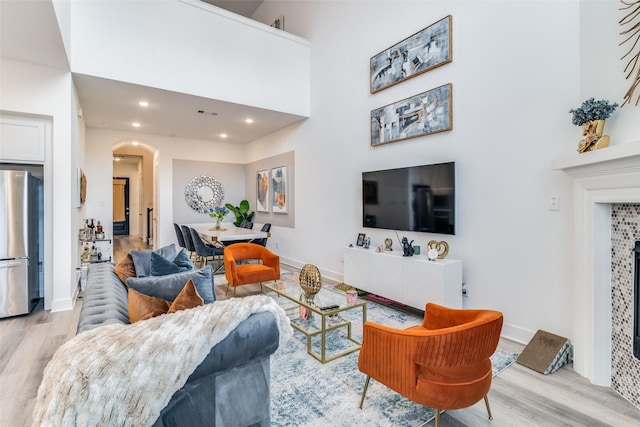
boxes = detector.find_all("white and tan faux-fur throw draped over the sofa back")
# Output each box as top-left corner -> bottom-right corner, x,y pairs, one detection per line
33,295 -> 293,426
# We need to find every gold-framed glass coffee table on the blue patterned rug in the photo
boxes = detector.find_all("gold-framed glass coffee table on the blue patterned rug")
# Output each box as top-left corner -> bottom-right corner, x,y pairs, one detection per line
262,281 -> 367,363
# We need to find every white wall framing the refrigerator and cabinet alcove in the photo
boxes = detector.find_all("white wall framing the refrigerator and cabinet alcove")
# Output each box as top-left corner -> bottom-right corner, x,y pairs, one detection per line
0,58 -> 83,311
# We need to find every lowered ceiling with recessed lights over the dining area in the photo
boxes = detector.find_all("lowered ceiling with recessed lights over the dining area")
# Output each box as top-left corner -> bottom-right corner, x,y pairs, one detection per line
73,74 -> 305,144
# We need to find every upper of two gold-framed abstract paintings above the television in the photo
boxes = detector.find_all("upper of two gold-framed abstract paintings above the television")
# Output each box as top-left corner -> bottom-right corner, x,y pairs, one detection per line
369,15 -> 452,93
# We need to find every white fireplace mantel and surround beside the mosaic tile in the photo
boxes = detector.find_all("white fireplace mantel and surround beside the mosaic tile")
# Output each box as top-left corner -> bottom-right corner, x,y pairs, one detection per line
552,141 -> 640,392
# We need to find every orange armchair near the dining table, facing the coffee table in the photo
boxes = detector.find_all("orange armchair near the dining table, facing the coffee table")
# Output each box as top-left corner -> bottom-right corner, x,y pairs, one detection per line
224,243 -> 280,295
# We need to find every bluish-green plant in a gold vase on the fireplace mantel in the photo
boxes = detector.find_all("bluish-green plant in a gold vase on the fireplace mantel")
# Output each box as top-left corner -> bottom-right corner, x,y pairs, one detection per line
569,98 -> 618,153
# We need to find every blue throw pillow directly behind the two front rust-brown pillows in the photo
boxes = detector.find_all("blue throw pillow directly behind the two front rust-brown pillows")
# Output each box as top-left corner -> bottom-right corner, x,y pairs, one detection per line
127,265 -> 216,304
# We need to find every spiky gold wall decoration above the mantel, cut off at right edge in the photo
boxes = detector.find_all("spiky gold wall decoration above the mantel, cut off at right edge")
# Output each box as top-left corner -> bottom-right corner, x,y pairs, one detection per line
618,0 -> 640,107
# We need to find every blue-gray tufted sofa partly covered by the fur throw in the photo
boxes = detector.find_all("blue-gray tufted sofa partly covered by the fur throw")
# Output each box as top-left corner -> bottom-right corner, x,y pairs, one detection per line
77,263 -> 279,427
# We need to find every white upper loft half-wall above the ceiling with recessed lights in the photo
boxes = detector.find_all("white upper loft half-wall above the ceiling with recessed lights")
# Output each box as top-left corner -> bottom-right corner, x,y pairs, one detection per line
70,0 -> 309,116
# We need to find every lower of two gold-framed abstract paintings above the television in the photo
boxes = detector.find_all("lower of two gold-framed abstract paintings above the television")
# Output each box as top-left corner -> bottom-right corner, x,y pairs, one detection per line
371,83 -> 453,147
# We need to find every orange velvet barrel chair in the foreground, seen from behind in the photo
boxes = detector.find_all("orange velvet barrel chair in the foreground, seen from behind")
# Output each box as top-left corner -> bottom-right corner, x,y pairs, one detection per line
358,303 -> 502,427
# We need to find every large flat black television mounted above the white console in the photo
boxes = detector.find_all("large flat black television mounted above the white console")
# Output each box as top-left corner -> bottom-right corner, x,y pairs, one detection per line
362,162 -> 455,234
